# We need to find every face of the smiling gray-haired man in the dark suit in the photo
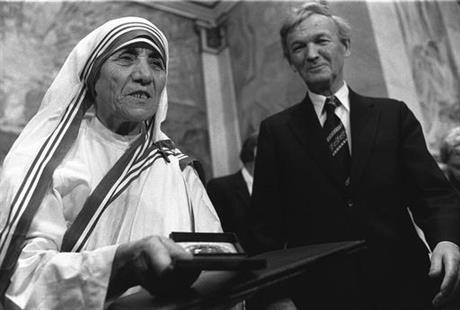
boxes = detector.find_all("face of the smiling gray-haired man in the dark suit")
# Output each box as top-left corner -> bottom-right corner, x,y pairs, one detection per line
286,14 -> 350,95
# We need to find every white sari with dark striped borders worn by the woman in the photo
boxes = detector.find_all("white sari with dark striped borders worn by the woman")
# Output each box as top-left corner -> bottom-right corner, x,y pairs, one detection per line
0,17 -> 221,309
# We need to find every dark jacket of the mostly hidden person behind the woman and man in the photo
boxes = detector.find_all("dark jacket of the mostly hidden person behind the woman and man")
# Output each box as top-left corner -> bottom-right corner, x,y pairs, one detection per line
207,170 -> 251,251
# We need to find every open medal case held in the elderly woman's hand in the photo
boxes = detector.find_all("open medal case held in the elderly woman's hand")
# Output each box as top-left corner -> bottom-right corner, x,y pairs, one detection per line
169,232 -> 267,270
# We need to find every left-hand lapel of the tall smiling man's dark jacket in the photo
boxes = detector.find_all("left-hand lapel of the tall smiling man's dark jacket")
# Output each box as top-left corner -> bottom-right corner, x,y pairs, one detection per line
288,94 -> 343,188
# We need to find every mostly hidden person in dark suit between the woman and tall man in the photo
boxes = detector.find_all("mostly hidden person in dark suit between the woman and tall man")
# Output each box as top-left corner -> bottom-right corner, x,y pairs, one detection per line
207,134 -> 257,251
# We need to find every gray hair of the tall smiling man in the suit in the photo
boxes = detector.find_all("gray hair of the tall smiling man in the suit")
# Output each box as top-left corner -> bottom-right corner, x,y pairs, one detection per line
280,1 -> 351,62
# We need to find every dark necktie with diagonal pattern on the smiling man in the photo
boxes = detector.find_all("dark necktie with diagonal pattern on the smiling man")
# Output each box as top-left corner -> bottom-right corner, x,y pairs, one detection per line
323,96 -> 351,186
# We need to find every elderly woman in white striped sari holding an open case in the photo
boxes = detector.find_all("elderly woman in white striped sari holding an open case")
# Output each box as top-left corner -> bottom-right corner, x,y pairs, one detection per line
0,17 -> 221,309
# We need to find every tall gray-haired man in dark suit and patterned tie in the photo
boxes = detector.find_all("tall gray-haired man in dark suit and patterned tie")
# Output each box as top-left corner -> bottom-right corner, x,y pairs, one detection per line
251,3 -> 460,310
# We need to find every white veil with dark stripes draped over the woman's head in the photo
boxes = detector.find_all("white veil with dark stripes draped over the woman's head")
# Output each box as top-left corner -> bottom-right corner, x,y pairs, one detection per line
0,17 -> 181,294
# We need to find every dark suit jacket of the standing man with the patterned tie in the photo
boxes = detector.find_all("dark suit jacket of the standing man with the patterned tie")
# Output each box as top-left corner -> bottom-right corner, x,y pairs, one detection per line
251,90 -> 460,309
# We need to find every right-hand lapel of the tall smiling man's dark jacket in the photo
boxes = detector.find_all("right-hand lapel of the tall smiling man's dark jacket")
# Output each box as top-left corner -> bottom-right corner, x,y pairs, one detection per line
350,89 -> 380,186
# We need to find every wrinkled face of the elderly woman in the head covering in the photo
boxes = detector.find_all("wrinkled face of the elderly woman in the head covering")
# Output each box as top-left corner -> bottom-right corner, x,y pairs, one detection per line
95,45 -> 166,134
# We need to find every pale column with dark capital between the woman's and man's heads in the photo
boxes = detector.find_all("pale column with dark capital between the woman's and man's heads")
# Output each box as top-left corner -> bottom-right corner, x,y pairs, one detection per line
197,21 -> 241,177
